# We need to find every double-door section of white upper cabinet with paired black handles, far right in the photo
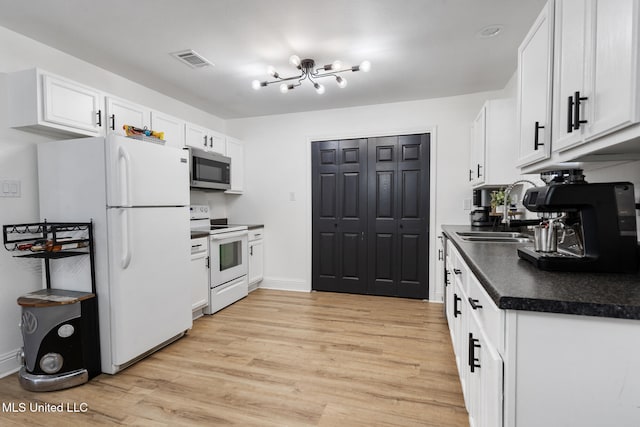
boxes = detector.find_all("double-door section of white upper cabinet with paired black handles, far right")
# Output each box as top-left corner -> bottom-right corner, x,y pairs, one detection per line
552,0 -> 639,152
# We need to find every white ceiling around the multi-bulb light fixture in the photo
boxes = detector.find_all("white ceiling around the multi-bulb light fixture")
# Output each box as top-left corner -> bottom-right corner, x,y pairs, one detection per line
0,0 -> 546,119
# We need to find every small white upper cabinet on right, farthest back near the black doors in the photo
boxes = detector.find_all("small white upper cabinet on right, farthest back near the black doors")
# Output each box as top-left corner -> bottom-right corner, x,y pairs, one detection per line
469,98 -> 520,187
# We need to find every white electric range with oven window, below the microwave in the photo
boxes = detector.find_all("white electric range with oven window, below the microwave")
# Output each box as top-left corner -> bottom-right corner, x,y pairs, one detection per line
191,205 -> 249,314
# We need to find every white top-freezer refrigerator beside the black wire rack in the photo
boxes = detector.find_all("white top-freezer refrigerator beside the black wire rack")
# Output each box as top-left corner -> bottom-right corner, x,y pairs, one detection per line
38,135 -> 192,374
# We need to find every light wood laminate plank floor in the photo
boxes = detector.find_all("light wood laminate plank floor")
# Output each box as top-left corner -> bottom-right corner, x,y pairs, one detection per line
0,289 -> 468,427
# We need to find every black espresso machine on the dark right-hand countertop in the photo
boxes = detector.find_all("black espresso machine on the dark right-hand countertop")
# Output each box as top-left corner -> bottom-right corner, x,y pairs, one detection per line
518,170 -> 638,273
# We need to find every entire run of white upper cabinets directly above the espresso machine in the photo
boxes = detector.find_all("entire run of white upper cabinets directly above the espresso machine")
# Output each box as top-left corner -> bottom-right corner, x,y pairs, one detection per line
518,0 -> 640,173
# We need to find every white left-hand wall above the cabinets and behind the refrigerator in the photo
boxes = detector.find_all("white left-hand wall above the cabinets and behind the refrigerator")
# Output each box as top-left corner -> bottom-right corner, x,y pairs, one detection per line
0,27 -> 226,377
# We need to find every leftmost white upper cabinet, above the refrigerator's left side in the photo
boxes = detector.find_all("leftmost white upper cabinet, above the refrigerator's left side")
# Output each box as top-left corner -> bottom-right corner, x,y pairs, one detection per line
8,69 -> 105,136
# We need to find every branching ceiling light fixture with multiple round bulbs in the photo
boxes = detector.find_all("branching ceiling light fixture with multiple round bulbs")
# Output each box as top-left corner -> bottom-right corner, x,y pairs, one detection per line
251,55 -> 371,95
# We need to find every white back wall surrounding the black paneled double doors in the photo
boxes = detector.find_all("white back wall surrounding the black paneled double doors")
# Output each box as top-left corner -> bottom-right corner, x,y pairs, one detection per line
227,91 -> 504,299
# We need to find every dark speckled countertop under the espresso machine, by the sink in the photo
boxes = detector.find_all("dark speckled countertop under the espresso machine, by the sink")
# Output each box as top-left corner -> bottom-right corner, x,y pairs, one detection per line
442,225 -> 640,319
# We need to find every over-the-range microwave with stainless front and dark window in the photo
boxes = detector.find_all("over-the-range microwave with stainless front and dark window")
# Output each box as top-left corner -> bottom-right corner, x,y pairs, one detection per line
189,148 -> 231,190
